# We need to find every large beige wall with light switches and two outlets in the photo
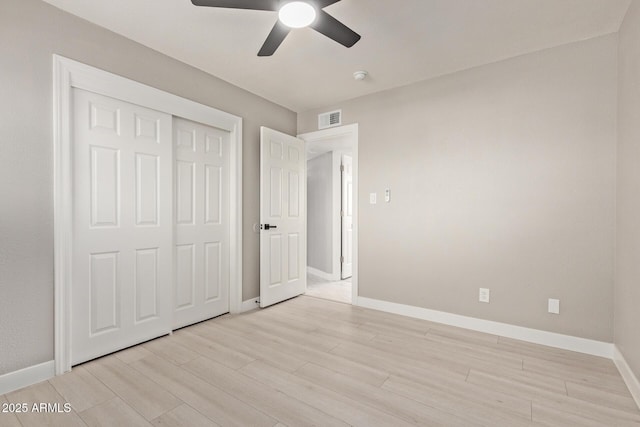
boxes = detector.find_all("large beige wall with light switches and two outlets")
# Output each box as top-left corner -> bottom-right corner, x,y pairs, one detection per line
298,35 -> 617,342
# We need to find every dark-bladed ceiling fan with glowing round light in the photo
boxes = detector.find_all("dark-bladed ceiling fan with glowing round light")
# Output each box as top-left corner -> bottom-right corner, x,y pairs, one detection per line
191,0 -> 360,56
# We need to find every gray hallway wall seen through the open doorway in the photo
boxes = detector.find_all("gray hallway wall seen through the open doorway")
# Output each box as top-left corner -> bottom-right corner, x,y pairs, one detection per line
307,152 -> 334,274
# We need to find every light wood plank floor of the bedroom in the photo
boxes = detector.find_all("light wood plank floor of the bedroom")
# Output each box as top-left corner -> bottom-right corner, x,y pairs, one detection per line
0,296 -> 640,427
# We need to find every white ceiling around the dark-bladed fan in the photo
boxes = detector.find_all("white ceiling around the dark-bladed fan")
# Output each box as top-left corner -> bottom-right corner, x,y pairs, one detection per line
45,0 -> 631,112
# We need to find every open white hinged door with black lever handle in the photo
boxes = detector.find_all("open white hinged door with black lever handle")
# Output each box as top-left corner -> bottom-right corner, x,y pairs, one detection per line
260,127 -> 307,307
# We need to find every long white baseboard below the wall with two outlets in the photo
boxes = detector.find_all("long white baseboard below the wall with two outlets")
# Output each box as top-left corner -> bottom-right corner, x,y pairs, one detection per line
354,297 -> 613,359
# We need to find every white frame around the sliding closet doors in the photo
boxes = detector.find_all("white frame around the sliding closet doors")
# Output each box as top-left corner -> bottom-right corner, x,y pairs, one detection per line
53,54 -> 242,375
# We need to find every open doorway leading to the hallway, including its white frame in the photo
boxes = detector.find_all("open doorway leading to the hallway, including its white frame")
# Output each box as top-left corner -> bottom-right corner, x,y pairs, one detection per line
298,124 -> 358,304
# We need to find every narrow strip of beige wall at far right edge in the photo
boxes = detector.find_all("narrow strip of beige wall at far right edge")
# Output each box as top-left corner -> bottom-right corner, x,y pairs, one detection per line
614,0 -> 640,378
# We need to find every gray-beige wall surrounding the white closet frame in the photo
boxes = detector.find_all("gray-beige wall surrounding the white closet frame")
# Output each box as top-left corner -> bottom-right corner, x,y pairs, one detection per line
0,0 -> 296,374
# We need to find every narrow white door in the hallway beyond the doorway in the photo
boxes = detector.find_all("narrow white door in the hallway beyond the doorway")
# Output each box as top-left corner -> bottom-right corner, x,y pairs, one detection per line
340,155 -> 353,279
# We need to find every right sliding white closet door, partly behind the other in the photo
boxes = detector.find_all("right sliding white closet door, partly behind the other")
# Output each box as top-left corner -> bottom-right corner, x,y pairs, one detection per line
173,118 -> 230,329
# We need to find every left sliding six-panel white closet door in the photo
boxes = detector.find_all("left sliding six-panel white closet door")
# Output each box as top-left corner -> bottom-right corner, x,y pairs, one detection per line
71,90 -> 173,365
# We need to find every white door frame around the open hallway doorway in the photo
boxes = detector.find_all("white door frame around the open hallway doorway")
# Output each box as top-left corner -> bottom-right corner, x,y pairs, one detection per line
298,123 -> 359,305
